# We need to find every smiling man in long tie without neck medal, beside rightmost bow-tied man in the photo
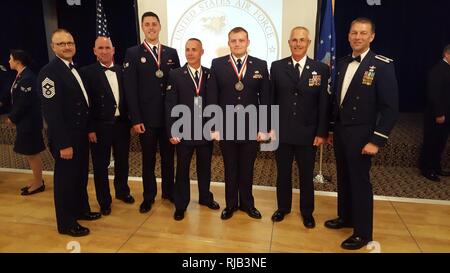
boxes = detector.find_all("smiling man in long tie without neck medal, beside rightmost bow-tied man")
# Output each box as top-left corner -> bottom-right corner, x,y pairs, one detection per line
270,27 -> 330,228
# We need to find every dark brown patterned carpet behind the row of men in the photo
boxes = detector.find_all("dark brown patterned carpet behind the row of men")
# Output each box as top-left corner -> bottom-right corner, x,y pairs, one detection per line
0,114 -> 450,200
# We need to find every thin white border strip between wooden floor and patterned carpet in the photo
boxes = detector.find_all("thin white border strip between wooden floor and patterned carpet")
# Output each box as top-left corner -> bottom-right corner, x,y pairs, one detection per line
0,168 -> 450,206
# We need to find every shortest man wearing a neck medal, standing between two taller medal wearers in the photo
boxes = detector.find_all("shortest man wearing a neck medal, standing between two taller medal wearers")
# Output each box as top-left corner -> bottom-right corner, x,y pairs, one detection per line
165,38 -> 220,221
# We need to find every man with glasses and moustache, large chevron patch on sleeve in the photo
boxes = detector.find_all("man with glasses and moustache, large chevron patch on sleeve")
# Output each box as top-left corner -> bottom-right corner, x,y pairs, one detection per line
38,29 -> 101,236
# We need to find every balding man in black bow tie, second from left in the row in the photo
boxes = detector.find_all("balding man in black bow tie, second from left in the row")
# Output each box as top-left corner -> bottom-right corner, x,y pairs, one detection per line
81,36 -> 134,215
